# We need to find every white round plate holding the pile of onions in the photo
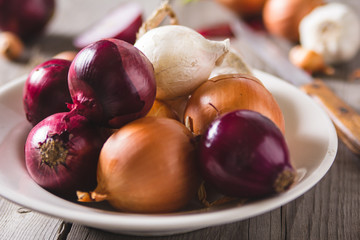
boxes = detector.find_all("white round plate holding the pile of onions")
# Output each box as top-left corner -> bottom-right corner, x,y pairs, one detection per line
0,71 -> 337,235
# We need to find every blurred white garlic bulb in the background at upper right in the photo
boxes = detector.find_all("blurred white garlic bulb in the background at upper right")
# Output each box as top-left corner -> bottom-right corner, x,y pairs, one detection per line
299,3 -> 360,64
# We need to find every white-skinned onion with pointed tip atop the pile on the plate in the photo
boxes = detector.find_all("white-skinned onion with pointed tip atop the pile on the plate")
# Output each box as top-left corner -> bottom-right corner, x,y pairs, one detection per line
135,25 -> 230,100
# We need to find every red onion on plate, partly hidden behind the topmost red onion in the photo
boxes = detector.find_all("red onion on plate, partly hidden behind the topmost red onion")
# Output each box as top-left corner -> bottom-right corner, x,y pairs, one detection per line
23,59 -> 72,126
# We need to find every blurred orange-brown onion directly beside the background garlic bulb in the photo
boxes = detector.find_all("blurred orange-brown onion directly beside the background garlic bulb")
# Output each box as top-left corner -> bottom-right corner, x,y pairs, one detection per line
263,0 -> 323,42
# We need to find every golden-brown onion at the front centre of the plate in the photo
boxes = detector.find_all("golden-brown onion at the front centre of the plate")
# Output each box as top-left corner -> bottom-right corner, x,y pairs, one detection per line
78,117 -> 199,213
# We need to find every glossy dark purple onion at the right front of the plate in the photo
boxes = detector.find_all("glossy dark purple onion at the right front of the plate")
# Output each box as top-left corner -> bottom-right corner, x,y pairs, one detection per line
199,110 -> 295,198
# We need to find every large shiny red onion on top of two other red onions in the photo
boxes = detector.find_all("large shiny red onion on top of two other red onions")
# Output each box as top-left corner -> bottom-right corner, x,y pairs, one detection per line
68,39 -> 156,128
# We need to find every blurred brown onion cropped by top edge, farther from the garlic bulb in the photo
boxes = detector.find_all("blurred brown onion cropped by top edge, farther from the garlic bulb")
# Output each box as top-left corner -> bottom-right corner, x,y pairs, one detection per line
216,0 -> 266,17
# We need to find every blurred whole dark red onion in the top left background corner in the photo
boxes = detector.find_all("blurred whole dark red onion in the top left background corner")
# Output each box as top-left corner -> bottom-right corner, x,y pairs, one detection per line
0,0 -> 56,40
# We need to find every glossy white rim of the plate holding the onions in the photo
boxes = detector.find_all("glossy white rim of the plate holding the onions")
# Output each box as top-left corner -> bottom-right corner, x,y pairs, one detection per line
0,69 -> 338,235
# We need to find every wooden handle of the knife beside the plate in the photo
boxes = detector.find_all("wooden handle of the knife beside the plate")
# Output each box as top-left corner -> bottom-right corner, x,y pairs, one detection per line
301,79 -> 360,155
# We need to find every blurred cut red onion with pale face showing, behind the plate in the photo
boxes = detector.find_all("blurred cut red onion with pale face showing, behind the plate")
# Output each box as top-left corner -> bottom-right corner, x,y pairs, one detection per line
74,2 -> 143,49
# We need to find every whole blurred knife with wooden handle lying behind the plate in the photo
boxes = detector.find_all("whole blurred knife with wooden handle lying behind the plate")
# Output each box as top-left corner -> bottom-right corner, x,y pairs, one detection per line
231,19 -> 360,155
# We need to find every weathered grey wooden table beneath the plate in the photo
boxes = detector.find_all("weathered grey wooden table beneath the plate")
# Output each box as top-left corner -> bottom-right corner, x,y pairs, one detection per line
0,0 -> 360,240
